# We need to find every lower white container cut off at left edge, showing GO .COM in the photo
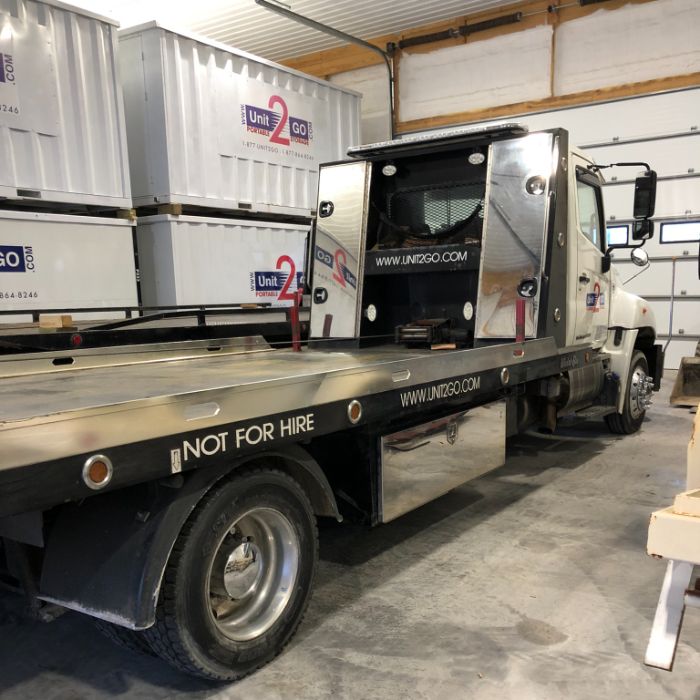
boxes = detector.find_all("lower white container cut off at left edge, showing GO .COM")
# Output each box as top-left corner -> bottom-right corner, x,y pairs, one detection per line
0,210 -> 138,323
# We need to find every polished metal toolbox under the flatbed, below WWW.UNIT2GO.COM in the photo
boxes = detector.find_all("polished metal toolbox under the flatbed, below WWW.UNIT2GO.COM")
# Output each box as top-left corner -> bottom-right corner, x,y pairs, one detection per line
379,401 -> 506,523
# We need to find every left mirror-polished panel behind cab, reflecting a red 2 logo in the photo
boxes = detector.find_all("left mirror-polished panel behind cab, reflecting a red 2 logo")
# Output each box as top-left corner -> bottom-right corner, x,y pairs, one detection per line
311,161 -> 371,338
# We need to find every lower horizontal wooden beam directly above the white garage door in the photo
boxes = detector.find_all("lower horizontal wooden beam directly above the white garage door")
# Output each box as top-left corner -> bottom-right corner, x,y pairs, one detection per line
396,72 -> 700,133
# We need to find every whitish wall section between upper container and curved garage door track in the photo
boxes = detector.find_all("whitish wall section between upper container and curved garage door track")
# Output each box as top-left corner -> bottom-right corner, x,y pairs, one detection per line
330,64 -> 392,145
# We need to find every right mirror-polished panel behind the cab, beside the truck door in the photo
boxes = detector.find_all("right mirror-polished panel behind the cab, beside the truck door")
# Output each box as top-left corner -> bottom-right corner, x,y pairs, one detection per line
476,133 -> 558,340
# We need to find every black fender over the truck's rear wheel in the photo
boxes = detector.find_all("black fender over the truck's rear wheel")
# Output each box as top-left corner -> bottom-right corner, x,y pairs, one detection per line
38,445 -> 342,630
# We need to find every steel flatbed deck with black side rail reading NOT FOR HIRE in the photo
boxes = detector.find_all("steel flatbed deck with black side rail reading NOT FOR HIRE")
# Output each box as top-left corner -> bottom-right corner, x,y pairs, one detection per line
0,337 -> 561,516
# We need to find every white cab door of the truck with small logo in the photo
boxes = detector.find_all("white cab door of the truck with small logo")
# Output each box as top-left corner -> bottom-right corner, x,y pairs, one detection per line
569,156 -> 610,347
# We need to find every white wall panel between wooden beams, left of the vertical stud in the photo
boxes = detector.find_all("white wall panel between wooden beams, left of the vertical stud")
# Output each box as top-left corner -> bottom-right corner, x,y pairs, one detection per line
399,26 -> 552,121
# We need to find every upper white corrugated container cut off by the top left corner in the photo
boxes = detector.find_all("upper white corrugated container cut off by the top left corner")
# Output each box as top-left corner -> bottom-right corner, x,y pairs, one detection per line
0,0 -> 131,207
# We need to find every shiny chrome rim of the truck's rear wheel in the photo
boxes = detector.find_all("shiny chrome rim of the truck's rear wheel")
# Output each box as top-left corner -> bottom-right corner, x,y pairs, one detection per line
207,508 -> 300,642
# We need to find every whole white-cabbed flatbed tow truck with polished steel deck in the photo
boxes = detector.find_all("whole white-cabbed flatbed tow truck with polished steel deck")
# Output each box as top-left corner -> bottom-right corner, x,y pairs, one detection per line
0,123 -> 663,680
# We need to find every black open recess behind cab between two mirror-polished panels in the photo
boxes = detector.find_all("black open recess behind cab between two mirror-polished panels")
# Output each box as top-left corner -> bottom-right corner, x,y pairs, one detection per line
360,146 -> 488,347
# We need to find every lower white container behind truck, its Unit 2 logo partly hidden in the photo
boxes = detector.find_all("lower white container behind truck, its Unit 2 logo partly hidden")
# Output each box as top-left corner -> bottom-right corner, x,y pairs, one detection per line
136,214 -> 309,306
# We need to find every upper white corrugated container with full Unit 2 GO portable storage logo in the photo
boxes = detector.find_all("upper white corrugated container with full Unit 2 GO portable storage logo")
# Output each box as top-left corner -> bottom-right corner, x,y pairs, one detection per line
119,22 -> 360,216
